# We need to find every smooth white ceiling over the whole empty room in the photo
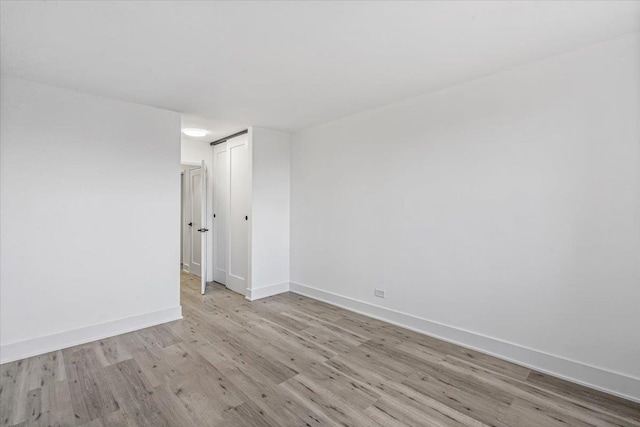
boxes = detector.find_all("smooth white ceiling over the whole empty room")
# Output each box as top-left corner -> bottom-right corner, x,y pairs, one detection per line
0,1 -> 640,138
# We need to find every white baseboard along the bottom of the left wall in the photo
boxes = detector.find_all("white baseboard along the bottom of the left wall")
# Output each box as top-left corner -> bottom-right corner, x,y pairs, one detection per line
0,306 -> 182,364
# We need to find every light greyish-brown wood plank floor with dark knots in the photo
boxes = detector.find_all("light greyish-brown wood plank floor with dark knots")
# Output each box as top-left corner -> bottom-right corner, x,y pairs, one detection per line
0,274 -> 640,427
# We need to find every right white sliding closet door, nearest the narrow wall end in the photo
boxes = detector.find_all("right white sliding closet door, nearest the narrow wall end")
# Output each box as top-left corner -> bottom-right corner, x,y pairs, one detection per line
226,135 -> 251,295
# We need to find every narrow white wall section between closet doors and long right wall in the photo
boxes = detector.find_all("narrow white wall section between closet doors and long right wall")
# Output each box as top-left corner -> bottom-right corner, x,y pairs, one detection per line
248,127 -> 291,299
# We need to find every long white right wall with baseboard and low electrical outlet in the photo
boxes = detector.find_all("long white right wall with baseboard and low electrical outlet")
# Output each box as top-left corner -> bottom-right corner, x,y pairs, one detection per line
291,34 -> 640,400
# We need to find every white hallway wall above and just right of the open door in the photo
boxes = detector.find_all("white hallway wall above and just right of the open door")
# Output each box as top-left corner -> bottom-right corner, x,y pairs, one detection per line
181,138 -> 213,282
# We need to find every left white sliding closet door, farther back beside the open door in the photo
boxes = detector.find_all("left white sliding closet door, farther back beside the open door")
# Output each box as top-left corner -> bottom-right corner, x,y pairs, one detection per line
213,142 -> 229,285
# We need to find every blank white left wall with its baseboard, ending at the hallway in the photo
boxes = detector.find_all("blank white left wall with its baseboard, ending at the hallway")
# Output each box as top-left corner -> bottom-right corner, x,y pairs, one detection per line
0,77 -> 181,361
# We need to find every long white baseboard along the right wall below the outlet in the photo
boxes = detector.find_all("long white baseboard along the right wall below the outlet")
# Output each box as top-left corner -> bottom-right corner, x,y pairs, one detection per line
289,282 -> 640,402
